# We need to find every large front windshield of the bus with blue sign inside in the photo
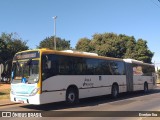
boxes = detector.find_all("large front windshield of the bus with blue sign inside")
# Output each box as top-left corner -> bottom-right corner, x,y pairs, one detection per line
12,59 -> 39,84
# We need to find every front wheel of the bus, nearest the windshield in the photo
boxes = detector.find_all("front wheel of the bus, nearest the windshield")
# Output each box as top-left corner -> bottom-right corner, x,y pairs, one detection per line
66,88 -> 79,105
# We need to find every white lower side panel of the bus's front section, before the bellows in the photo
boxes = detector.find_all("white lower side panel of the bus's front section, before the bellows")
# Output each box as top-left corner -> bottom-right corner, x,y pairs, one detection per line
42,75 -> 126,102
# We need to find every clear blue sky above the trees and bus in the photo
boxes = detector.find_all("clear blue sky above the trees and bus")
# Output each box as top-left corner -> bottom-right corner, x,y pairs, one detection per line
0,0 -> 160,65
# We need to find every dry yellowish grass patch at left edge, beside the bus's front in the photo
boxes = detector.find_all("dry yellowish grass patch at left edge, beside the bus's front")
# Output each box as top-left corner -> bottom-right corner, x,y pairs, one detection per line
0,88 -> 10,100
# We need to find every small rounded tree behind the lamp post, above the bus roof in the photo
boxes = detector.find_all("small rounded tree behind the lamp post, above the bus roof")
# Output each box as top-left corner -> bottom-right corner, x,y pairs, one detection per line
37,36 -> 70,50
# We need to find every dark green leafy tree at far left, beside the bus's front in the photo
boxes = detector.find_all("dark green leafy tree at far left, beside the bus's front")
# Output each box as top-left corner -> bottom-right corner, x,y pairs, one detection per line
0,33 -> 29,61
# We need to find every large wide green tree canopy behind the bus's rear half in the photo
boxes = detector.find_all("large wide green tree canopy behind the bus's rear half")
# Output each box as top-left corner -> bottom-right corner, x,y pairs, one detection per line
76,33 -> 154,63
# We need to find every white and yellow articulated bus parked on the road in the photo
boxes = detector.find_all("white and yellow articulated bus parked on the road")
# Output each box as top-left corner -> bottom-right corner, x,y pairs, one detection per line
10,49 -> 155,105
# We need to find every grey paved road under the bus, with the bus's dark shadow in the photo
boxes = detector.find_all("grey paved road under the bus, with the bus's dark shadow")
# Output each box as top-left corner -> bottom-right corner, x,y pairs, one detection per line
0,87 -> 160,120
